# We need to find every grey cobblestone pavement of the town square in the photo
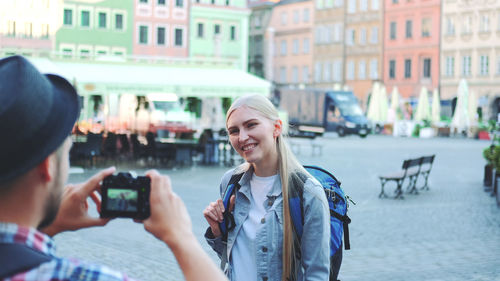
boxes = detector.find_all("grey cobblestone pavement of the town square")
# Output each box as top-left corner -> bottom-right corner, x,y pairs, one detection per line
56,136 -> 500,281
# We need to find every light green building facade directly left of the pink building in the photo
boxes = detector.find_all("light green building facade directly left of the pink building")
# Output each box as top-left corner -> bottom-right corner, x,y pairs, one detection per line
55,0 -> 134,59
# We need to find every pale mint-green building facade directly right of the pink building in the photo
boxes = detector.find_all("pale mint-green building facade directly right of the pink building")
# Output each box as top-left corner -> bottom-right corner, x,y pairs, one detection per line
189,0 -> 250,71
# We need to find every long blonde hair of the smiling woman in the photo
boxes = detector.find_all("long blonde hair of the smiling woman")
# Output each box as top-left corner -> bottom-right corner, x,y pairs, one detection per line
226,95 -> 308,281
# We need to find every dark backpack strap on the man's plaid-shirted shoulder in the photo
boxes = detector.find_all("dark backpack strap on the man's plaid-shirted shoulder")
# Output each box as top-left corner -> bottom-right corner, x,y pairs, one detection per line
0,243 -> 52,280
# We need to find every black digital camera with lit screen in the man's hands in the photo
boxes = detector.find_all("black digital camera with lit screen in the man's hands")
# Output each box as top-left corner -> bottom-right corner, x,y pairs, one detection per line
100,173 -> 151,220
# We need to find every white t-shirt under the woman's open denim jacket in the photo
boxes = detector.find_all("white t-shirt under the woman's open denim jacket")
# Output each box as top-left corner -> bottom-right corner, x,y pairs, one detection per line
231,174 -> 278,281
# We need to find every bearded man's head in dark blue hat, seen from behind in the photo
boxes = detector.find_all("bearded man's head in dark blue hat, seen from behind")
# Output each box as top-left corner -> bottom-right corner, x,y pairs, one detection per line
0,56 -> 79,226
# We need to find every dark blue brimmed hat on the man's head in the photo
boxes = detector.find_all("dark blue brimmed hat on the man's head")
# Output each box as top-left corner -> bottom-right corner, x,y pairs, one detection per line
0,56 -> 79,183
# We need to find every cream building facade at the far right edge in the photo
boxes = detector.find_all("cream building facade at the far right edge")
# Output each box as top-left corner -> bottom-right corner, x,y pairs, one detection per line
441,0 -> 500,119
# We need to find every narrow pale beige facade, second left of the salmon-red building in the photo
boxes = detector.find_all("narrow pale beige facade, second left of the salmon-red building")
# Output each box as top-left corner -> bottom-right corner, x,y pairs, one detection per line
312,0 -> 345,89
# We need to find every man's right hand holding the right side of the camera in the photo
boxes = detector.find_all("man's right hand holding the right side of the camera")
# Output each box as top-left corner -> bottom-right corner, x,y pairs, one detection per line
144,170 -> 194,245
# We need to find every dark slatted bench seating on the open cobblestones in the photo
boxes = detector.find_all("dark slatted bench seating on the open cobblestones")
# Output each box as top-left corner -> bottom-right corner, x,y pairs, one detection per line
379,155 -> 435,199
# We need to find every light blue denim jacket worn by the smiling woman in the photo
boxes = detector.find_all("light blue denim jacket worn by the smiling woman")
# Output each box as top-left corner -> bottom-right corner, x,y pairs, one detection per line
205,168 -> 330,281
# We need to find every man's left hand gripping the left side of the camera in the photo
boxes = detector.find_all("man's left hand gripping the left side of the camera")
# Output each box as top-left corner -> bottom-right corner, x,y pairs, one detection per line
41,167 -> 115,236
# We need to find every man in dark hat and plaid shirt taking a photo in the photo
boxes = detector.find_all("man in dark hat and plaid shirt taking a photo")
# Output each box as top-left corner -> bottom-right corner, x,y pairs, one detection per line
0,56 -> 227,280
